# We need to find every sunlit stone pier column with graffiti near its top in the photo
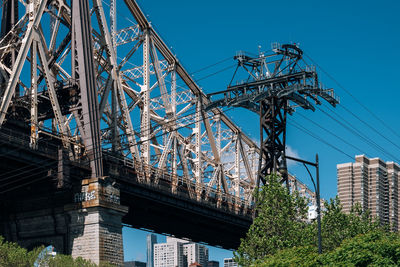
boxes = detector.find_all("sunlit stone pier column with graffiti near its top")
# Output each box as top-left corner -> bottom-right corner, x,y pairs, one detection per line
66,179 -> 128,266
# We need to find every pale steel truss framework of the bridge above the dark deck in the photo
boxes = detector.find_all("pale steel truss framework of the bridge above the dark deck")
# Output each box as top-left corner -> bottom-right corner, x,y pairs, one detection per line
0,0 -> 259,205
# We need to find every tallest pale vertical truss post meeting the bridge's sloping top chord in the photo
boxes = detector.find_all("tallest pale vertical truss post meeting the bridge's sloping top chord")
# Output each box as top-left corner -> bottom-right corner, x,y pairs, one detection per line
140,30 -> 150,176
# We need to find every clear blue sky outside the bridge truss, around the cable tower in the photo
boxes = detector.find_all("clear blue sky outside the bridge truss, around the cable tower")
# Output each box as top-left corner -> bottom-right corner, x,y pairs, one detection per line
119,0 -> 400,260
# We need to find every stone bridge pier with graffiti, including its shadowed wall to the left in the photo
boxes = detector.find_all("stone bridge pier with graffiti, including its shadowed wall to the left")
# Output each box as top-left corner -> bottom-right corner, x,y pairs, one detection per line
0,179 -> 128,266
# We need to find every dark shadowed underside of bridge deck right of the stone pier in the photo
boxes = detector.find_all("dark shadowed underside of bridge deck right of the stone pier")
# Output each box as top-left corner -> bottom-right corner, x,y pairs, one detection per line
121,179 -> 251,249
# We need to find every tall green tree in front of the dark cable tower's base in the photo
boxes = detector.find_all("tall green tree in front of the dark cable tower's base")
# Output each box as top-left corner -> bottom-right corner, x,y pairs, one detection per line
234,175 -> 314,266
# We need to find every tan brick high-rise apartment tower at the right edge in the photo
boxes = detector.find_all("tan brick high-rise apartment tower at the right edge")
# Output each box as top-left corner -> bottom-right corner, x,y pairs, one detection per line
337,155 -> 400,231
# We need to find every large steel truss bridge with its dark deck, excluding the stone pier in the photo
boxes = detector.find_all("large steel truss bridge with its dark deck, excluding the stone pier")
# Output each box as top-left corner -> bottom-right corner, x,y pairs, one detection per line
0,0 -> 314,255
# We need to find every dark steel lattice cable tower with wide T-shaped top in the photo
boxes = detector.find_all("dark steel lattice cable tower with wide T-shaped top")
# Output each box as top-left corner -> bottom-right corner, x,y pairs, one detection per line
204,44 -> 339,187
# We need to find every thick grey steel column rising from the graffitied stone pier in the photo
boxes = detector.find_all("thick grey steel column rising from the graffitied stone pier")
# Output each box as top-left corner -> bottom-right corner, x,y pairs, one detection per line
71,0 -> 103,177
